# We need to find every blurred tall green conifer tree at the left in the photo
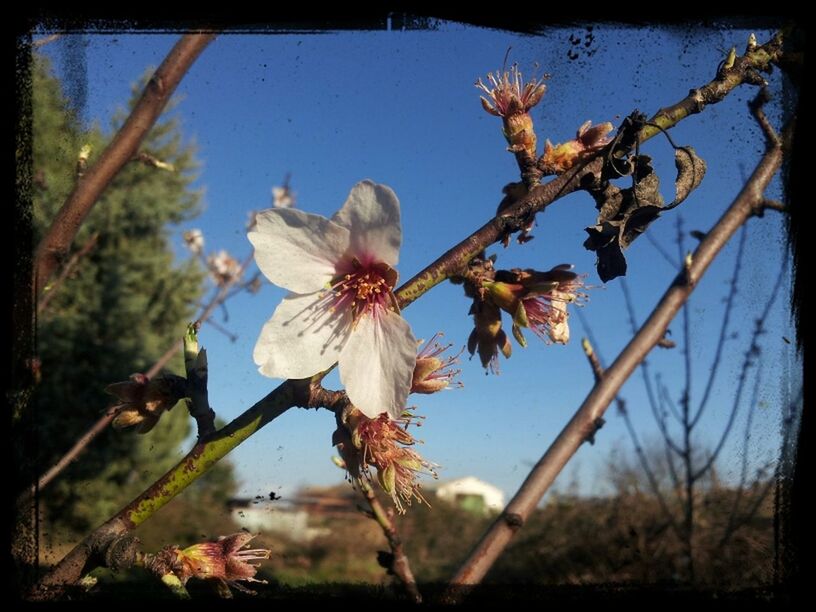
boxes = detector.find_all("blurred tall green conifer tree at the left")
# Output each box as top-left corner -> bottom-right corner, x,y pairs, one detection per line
27,57 -> 234,535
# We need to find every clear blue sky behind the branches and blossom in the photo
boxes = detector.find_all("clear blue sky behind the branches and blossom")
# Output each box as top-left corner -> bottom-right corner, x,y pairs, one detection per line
36,23 -> 801,502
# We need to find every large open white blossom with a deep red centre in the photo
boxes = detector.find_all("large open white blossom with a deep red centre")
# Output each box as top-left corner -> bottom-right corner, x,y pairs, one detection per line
249,181 -> 417,418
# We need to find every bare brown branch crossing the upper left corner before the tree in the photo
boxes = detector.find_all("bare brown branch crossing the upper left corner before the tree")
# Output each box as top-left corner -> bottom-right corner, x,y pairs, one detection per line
34,33 -> 215,296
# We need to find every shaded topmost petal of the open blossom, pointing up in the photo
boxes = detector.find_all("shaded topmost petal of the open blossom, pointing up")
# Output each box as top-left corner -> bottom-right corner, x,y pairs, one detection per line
332,180 -> 402,266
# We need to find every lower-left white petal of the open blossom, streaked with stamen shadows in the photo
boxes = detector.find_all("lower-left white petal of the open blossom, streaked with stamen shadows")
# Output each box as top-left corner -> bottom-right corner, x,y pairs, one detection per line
252,291 -> 352,378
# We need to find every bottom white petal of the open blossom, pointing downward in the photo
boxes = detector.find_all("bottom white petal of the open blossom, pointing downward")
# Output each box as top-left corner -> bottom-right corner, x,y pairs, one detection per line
340,310 -> 417,419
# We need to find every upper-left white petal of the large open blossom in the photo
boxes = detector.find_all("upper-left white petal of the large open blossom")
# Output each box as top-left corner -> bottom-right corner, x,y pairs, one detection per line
249,208 -> 349,294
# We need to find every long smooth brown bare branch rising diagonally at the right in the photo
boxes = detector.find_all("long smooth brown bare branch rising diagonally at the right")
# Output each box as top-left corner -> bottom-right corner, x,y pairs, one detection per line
444,124 -> 782,601
